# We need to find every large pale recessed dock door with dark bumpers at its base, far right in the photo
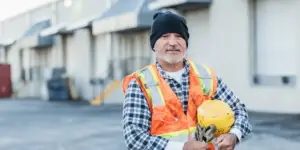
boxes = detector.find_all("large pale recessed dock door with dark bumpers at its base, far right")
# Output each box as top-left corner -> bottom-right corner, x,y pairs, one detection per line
253,0 -> 299,86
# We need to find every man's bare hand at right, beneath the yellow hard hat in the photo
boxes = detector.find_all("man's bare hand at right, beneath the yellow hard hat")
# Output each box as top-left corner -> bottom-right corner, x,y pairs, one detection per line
215,134 -> 237,150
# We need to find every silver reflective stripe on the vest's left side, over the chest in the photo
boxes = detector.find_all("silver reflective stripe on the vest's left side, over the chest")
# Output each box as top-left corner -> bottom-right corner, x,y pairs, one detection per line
141,66 -> 164,107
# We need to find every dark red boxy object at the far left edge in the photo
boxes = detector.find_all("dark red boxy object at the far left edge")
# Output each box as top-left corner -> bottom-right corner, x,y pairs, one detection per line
0,64 -> 12,98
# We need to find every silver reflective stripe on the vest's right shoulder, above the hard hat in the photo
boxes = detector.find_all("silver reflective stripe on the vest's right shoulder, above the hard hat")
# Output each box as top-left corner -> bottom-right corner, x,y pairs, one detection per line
195,64 -> 213,95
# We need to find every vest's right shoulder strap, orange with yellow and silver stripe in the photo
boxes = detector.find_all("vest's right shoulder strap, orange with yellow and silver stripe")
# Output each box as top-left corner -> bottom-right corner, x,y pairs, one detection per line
188,60 -> 217,98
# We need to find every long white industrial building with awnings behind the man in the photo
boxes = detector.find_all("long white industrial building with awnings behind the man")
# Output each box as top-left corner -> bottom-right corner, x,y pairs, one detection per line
0,0 -> 300,113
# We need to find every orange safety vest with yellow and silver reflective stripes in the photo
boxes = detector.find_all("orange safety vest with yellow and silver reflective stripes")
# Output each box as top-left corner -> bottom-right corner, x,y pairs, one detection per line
122,59 -> 217,150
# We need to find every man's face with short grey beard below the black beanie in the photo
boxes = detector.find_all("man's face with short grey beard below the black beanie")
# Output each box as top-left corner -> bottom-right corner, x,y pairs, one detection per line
153,33 -> 186,63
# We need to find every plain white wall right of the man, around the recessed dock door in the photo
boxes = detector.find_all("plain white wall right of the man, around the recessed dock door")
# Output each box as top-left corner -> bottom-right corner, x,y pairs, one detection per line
186,0 -> 300,113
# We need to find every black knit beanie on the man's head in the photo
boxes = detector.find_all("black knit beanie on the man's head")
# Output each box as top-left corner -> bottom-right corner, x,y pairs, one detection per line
150,11 -> 190,50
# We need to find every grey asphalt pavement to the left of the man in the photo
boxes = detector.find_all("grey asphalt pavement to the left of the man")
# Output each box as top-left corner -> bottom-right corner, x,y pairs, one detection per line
0,100 -> 125,150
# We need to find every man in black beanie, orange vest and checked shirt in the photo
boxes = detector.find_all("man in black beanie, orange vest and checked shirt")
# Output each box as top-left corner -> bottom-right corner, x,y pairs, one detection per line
123,11 -> 252,150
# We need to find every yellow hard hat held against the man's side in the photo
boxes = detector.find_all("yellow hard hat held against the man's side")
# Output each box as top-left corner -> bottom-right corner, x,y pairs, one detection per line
197,100 -> 235,137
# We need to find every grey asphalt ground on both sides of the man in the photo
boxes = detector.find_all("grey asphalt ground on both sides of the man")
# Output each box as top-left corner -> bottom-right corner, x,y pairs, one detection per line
0,99 -> 300,150
